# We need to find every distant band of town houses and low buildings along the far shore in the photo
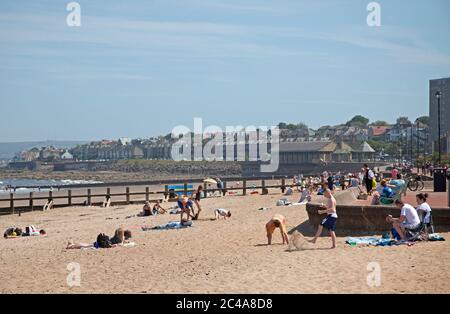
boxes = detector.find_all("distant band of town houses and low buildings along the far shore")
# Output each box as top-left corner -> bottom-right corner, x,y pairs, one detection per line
10,118 -> 430,162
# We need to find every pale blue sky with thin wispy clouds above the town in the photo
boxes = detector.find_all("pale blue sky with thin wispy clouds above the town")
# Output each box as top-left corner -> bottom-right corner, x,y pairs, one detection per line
0,0 -> 450,142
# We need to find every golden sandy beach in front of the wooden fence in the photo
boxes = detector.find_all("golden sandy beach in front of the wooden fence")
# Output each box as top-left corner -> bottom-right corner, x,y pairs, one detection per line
0,190 -> 450,293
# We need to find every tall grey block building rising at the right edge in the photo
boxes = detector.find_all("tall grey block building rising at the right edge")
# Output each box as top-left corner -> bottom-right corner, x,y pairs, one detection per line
429,78 -> 450,154
